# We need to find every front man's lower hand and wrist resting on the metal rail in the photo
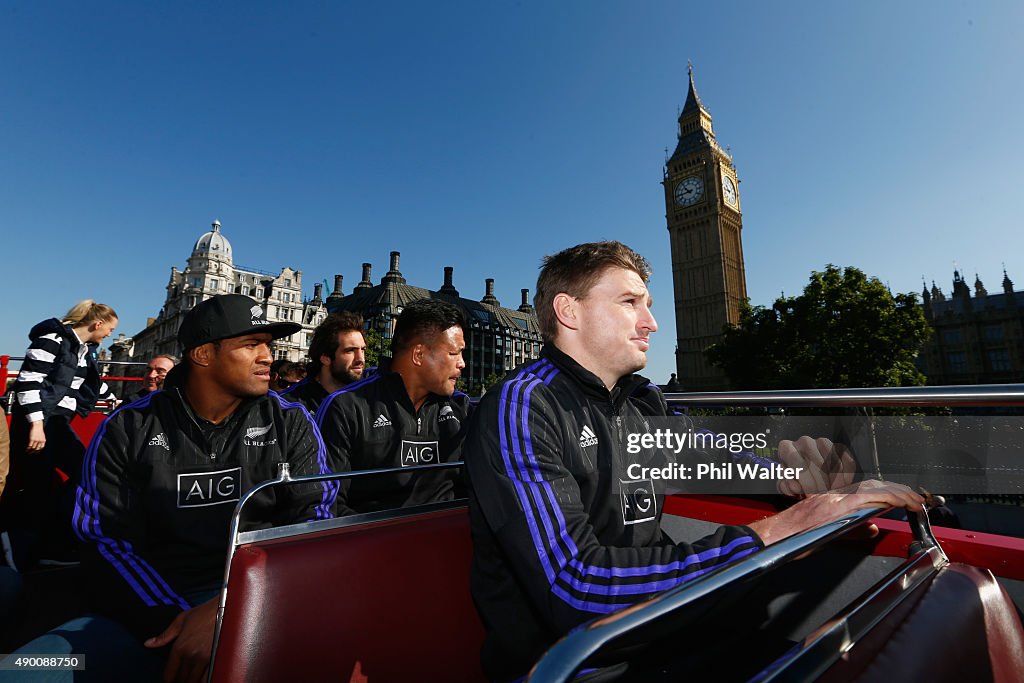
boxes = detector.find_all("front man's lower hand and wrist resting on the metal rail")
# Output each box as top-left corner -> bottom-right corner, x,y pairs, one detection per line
750,479 -> 925,546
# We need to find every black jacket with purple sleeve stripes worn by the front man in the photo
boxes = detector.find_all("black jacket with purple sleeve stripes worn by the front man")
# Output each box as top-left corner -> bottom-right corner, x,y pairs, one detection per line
465,344 -> 764,680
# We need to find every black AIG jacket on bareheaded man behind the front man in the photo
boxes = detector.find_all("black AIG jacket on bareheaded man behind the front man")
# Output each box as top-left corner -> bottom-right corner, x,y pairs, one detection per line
316,372 -> 469,516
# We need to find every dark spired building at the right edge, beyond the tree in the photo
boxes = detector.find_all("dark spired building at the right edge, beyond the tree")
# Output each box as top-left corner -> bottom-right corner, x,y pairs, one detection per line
919,270 -> 1024,385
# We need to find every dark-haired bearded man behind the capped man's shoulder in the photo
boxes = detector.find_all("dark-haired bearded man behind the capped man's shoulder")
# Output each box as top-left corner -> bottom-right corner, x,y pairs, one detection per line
282,311 -> 367,415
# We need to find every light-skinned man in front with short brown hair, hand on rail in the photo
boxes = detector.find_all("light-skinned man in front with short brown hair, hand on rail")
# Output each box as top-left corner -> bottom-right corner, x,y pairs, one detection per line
465,242 -> 921,681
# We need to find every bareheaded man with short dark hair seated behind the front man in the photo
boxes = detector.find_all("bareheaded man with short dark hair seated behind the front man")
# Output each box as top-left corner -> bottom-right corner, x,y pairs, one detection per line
316,299 -> 469,515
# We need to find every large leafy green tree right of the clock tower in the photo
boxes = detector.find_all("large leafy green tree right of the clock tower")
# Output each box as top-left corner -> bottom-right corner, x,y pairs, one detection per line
707,263 -> 931,390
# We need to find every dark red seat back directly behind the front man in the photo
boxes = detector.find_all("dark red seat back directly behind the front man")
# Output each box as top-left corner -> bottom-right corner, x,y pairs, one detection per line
213,507 -> 483,683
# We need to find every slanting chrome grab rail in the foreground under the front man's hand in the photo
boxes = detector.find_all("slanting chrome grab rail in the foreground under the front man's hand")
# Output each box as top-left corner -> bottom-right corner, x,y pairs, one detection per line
526,508 -> 948,683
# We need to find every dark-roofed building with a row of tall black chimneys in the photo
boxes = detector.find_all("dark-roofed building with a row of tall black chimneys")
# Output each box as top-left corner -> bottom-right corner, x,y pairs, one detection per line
327,252 -> 542,393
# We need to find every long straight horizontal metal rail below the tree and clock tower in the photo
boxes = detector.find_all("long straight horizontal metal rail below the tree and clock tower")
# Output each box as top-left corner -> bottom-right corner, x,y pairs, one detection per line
665,384 -> 1024,408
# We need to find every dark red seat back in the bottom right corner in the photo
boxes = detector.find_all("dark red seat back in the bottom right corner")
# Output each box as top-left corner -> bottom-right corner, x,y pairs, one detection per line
818,564 -> 1024,683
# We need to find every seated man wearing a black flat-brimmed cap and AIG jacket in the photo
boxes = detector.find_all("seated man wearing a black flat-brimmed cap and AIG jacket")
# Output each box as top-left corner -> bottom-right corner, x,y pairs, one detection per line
0,294 -> 335,681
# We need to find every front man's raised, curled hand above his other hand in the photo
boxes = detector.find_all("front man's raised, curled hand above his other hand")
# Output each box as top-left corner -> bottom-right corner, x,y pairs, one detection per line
778,436 -> 857,498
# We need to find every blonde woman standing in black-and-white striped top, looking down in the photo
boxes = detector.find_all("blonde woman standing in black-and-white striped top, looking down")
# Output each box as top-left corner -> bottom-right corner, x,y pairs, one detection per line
2,299 -> 118,569
